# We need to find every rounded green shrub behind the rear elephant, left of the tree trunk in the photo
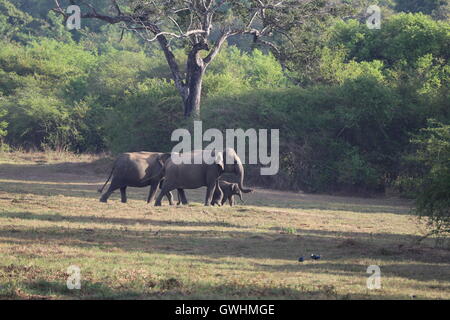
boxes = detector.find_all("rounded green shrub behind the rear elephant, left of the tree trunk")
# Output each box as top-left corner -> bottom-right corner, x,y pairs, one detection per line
104,79 -> 186,152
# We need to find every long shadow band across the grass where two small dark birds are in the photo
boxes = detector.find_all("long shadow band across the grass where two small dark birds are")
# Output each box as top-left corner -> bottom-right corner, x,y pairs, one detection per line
0,214 -> 450,281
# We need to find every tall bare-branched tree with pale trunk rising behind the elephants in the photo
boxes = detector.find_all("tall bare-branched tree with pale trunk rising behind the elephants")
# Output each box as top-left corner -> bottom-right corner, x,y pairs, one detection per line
53,0 -> 324,118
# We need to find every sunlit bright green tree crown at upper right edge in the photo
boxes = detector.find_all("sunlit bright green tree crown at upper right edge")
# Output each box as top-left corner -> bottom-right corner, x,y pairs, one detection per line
330,13 -> 450,67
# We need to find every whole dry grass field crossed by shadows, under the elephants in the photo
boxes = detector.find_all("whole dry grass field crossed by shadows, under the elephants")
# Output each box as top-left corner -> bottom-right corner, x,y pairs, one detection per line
0,153 -> 450,299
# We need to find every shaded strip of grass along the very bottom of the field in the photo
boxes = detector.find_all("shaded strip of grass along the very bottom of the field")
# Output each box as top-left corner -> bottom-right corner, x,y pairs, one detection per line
0,278 -> 418,300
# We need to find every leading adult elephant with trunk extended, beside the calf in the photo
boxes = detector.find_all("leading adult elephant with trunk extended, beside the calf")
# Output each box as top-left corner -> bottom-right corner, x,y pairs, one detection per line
155,148 -> 252,206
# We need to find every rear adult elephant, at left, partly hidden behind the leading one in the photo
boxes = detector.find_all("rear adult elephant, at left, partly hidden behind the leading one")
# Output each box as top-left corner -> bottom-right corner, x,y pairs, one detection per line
98,151 -> 173,205
